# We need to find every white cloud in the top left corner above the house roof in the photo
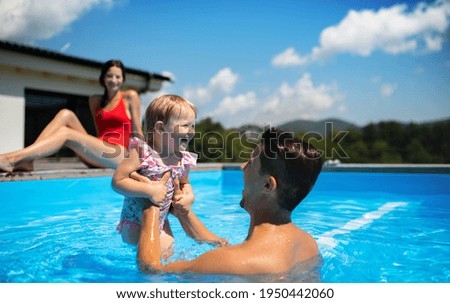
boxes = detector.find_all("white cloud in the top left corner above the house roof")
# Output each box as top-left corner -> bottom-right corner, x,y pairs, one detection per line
0,0 -> 113,43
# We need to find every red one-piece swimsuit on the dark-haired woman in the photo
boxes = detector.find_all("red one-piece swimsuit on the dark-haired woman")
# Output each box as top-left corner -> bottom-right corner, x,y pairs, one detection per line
95,96 -> 131,149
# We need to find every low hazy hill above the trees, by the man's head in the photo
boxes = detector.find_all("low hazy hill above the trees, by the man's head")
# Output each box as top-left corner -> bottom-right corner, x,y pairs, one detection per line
277,118 -> 360,134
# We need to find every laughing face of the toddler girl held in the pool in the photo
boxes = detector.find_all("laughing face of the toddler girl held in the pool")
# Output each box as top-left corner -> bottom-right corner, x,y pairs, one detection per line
164,107 -> 195,157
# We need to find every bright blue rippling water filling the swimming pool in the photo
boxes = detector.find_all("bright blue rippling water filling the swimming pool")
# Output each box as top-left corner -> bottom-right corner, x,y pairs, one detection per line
0,171 -> 450,282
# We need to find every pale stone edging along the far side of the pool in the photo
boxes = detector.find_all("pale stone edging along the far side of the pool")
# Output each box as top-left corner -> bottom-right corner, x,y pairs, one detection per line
0,158 -> 450,182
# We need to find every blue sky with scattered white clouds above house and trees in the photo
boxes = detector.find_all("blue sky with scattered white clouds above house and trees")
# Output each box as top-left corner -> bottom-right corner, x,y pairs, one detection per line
0,0 -> 450,127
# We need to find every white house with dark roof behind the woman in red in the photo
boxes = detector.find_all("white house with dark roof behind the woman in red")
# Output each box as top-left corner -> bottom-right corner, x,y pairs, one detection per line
0,40 -> 171,154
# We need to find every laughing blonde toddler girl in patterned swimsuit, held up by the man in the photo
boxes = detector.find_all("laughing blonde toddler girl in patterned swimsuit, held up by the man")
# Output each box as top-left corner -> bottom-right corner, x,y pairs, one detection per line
112,95 -> 225,249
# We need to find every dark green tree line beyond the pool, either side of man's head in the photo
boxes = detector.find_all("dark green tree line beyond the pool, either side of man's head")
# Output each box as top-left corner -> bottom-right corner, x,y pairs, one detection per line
190,118 -> 450,163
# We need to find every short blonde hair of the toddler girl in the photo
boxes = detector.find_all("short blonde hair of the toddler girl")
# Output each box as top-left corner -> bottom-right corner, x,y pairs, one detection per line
144,95 -> 197,143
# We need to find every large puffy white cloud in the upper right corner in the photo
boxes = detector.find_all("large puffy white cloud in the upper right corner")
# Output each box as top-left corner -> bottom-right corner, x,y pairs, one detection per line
298,1 -> 450,66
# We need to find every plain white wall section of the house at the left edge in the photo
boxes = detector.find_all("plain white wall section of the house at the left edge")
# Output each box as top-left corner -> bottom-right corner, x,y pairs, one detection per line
0,95 -> 25,154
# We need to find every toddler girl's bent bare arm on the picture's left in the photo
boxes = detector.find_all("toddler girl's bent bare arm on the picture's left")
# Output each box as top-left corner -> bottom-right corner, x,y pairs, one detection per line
111,148 -> 170,206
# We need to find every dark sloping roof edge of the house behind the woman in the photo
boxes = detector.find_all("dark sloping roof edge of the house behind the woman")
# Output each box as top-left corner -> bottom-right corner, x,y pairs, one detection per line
0,40 -> 172,81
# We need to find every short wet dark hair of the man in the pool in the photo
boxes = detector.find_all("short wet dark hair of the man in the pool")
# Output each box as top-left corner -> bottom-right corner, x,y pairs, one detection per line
260,128 -> 322,211
